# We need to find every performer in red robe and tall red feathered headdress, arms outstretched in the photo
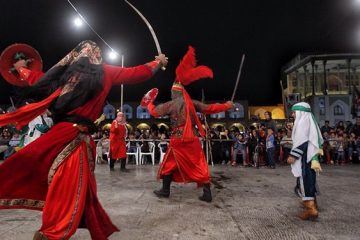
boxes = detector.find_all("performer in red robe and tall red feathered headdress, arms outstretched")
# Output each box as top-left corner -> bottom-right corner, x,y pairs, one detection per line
147,47 -> 233,202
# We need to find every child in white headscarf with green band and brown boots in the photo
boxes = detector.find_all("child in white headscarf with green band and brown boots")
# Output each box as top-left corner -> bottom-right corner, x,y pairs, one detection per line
287,102 -> 324,220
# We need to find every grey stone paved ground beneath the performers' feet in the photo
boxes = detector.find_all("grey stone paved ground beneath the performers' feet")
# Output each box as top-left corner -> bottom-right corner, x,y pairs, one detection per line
0,162 -> 360,240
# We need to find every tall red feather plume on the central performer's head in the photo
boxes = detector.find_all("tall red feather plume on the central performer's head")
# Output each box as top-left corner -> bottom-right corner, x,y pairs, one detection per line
175,46 -> 213,86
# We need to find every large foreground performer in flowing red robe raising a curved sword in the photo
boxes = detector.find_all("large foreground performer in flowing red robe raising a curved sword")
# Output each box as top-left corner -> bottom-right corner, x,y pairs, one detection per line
0,41 -> 167,240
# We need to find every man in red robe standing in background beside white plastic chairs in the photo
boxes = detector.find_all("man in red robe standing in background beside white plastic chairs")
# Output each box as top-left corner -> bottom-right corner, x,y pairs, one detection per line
109,112 -> 127,172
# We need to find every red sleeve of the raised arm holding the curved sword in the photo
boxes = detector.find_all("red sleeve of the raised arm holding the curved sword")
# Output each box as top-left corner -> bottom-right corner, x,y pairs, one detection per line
104,64 -> 153,84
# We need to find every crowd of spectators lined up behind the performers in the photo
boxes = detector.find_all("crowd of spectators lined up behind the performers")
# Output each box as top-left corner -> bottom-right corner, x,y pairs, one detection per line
90,112 -> 360,168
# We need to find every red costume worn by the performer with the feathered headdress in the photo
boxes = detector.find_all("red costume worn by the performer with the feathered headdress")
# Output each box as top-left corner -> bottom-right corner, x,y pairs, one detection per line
148,98 -> 232,185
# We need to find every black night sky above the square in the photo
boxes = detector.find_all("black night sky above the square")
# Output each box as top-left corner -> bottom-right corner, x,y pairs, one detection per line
0,0 -> 360,105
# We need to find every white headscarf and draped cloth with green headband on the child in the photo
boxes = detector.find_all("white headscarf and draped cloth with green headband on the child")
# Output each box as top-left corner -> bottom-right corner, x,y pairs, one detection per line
291,102 -> 324,177
